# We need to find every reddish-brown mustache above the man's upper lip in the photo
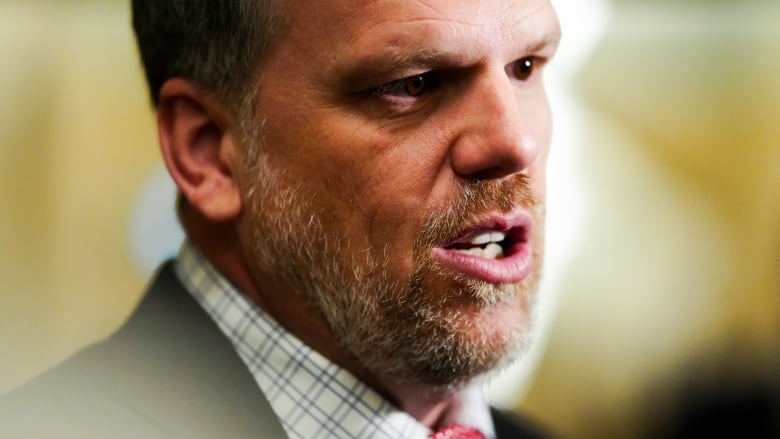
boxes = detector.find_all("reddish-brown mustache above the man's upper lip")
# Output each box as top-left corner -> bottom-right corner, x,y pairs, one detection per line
415,174 -> 539,251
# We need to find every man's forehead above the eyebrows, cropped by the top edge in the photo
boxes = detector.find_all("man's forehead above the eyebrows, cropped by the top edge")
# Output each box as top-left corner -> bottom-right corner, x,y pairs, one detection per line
280,0 -> 559,58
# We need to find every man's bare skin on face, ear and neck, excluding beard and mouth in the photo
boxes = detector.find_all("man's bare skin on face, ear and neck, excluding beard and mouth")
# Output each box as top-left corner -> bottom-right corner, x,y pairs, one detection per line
158,0 -> 560,426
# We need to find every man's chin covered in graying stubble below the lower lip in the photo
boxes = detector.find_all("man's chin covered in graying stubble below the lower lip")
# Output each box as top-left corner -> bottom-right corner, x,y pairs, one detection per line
370,275 -> 532,391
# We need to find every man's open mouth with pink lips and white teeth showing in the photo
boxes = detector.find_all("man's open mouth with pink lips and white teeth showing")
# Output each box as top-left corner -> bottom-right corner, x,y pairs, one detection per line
433,213 -> 533,283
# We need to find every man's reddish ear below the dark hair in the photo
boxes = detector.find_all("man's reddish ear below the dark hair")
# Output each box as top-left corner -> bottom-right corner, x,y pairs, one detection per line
157,79 -> 241,222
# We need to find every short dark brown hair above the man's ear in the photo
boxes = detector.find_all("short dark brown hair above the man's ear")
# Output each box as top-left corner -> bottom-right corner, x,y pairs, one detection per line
132,0 -> 284,112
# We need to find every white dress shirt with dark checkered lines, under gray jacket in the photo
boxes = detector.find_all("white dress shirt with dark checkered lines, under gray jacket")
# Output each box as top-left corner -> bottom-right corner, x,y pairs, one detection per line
175,242 -> 494,439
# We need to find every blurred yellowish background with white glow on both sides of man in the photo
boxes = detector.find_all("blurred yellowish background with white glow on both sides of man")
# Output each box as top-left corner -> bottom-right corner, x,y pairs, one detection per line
0,0 -> 780,439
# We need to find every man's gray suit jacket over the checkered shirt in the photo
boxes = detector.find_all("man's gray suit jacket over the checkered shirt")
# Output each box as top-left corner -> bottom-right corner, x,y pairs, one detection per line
0,263 -> 541,438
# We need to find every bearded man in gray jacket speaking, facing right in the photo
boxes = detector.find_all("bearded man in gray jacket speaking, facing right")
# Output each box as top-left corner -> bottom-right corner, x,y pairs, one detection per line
0,0 -> 559,438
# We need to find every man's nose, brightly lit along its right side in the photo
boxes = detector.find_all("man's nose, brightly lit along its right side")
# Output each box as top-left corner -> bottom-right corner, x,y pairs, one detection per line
450,71 -> 549,179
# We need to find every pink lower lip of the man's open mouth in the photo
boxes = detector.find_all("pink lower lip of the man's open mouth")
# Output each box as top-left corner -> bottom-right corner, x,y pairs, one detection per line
433,242 -> 533,284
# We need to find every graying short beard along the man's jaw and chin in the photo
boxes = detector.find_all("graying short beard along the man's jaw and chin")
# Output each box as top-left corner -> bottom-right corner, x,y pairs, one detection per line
245,154 -> 540,391
